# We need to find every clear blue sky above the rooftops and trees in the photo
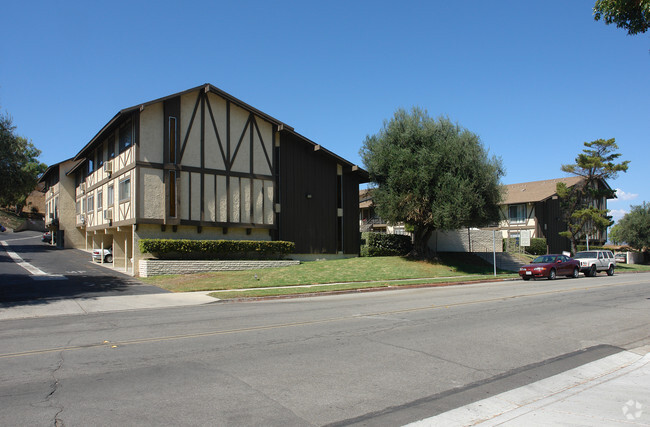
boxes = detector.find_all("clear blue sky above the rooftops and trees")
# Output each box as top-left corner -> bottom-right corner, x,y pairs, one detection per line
0,0 -> 650,224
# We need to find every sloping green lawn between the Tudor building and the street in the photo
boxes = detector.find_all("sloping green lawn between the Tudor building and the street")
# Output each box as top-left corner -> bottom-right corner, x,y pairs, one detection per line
142,254 -> 516,299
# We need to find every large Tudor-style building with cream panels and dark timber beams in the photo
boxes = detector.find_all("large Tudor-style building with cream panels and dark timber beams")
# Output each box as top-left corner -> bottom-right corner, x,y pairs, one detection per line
67,84 -> 368,272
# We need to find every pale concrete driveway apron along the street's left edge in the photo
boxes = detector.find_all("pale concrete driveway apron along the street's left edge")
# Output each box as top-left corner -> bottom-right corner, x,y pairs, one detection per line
0,292 -> 219,320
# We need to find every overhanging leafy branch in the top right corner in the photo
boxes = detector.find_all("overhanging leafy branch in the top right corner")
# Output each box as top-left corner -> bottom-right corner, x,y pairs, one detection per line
594,0 -> 650,35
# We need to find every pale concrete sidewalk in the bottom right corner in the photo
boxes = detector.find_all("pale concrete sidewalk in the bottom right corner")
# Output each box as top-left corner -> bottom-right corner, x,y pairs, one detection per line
409,346 -> 650,427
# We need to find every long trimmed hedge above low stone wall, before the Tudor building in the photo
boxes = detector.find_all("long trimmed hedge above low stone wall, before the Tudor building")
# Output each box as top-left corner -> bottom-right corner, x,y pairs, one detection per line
139,239 -> 296,259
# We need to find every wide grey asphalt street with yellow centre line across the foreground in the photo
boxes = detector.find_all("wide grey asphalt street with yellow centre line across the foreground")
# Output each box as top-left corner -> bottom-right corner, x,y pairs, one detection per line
0,268 -> 650,426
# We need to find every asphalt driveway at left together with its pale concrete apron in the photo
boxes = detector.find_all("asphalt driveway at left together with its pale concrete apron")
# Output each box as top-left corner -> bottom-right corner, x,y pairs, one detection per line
0,231 -> 216,320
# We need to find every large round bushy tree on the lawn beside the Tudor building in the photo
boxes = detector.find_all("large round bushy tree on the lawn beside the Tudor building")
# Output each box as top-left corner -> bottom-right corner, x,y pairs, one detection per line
360,107 -> 504,258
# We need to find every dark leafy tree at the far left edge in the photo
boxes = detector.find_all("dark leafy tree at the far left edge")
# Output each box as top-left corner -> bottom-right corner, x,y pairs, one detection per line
0,110 -> 47,211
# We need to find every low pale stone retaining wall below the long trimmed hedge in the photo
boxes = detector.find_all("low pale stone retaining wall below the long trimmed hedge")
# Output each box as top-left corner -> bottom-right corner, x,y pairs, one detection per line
140,259 -> 300,277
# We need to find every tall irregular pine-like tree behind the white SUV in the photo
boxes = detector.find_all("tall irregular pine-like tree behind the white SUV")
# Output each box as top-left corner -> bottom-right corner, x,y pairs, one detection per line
557,138 -> 630,253
